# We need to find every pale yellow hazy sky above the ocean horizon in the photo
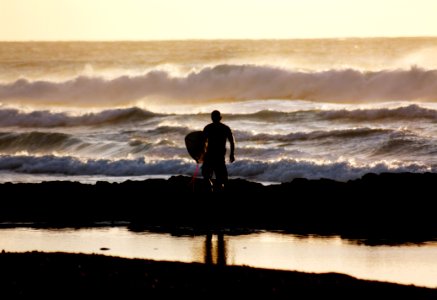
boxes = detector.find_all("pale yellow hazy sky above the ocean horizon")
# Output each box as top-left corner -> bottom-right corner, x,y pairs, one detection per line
0,0 -> 437,40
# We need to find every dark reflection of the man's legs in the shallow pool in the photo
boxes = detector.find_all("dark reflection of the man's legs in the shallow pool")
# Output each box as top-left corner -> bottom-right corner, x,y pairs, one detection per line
203,232 -> 227,266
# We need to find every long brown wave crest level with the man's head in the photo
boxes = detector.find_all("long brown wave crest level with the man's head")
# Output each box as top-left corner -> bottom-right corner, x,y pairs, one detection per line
0,104 -> 437,127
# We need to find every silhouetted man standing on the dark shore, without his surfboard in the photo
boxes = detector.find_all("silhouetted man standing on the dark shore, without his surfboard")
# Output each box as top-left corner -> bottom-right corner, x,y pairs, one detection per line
202,110 -> 235,191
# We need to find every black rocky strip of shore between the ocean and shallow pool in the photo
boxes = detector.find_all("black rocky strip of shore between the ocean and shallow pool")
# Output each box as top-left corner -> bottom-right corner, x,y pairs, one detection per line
0,173 -> 437,241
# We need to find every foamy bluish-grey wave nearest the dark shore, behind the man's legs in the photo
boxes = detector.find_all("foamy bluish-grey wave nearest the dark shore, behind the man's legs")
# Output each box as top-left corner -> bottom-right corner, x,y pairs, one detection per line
0,155 -> 435,182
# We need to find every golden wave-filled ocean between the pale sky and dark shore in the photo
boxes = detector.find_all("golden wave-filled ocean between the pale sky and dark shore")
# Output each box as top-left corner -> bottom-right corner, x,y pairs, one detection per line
0,38 -> 437,184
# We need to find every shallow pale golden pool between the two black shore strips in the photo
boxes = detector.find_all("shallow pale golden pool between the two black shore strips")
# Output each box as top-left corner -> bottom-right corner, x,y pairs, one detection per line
0,227 -> 437,288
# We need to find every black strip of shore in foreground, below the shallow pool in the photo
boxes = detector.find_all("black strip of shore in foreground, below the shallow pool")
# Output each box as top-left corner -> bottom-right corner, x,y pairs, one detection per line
0,252 -> 437,299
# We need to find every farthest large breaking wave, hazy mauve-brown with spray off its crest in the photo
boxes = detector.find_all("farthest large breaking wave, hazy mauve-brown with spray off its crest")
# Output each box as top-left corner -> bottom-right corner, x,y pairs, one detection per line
0,64 -> 437,106
